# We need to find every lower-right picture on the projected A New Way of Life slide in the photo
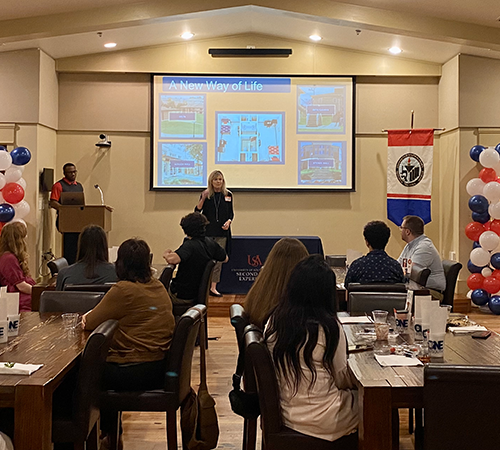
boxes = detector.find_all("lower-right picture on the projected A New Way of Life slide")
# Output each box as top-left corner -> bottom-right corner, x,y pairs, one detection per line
298,141 -> 345,186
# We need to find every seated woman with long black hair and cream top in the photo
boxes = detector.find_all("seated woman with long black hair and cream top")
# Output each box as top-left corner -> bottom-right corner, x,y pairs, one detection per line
265,255 -> 358,450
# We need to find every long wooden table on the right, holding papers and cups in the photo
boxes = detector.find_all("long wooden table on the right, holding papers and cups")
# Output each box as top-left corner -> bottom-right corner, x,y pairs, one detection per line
344,325 -> 500,450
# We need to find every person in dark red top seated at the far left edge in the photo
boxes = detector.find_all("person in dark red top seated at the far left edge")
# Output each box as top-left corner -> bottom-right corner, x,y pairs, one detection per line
0,222 -> 35,312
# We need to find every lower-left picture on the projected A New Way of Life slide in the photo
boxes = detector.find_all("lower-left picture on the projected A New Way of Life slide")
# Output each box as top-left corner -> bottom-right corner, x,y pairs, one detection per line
158,142 -> 207,187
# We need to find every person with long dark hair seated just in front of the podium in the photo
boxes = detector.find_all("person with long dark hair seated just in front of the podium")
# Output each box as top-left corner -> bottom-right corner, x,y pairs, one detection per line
56,225 -> 117,291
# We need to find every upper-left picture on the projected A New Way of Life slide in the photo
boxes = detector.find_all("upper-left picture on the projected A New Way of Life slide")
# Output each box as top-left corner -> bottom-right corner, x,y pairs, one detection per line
160,95 -> 205,139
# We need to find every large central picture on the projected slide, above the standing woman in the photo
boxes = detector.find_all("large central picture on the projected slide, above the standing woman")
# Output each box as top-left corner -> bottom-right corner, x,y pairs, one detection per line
215,112 -> 285,164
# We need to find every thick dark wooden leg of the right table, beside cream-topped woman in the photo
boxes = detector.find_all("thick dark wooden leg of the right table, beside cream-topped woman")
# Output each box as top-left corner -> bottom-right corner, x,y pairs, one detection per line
358,382 -> 394,450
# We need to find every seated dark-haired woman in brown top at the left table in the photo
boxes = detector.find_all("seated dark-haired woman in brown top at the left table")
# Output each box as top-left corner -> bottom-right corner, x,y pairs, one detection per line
82,239 -> 175,446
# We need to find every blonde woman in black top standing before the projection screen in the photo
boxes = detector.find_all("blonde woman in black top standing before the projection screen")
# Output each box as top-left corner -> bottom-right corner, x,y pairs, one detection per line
194,170 -> 234,297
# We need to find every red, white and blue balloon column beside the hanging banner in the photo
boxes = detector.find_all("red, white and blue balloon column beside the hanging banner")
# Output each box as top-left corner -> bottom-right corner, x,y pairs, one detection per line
465,144 -> 500,314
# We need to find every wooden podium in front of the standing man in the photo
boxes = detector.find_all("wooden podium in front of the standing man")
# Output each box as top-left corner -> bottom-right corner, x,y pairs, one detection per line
59,205 -> 111,233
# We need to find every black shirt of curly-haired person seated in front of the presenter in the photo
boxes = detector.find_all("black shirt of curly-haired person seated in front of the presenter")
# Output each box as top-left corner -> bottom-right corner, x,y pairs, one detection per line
170,237 -> 226,300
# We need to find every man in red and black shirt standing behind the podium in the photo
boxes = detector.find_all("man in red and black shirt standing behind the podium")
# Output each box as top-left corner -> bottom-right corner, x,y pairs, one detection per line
50,163 -> 84,264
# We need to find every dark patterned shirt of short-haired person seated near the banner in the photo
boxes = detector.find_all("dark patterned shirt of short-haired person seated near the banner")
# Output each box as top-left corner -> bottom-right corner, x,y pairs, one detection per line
344,250 -> 404,287
